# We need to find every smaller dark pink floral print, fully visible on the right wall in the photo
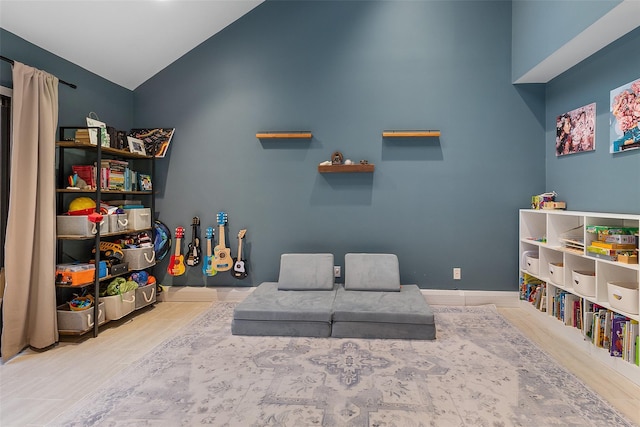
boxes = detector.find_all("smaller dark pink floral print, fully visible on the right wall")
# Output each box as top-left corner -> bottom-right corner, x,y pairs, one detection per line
556,102 -> 596,156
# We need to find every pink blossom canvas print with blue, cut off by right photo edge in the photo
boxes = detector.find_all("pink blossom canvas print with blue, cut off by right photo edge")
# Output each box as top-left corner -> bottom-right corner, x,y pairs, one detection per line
609,79 -> 640,153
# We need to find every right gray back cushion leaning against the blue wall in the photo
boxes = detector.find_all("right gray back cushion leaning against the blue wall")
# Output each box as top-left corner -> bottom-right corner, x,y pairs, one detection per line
344,254 -> 400,292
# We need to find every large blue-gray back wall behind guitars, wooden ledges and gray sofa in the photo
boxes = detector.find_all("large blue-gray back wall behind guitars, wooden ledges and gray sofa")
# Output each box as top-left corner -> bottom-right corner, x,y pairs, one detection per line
134,1 -> 545,290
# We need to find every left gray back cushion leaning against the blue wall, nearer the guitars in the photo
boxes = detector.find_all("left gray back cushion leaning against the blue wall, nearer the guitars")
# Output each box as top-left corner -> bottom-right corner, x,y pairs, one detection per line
278,254 -> 333,291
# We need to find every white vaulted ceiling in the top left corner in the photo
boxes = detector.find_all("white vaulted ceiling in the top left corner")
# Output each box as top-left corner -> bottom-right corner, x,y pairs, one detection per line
0,0 -> 264,90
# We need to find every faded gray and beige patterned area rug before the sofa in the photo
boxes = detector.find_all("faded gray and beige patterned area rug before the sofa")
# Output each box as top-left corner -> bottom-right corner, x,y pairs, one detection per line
49,303 -> 633,427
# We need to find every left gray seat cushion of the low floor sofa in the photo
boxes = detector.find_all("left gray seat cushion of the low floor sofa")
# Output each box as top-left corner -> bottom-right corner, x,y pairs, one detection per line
233,282 -> 337,322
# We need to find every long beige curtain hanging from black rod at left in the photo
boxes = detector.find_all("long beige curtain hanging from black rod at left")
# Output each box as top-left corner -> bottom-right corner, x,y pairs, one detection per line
2,62 -> 58,361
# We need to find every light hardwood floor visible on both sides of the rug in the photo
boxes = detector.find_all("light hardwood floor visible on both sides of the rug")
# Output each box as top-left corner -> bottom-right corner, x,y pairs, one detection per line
0,301 -> 640,427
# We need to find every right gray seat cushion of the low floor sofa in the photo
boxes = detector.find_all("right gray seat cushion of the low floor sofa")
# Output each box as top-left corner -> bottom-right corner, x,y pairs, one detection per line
333,285 -> 434,324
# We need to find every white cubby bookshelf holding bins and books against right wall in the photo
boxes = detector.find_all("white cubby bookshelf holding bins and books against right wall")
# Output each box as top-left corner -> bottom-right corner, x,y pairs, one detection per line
519,209 -> 640,385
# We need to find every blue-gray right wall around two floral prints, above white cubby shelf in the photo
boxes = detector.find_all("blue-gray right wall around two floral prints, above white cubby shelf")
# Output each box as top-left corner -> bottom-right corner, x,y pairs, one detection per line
545,28 -> 640,214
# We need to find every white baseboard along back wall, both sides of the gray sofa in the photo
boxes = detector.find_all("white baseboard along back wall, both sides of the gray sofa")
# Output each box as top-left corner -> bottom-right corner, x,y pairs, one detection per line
158,286 -> 519,307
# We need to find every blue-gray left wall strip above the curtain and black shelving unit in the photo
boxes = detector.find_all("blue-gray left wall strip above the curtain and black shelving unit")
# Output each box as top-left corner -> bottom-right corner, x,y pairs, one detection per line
0,28 -> 133,129
